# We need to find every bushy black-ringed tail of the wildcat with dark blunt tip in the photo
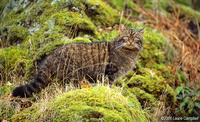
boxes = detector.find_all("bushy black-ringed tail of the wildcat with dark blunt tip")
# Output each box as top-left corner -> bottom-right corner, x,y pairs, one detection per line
12,76 -> 48,98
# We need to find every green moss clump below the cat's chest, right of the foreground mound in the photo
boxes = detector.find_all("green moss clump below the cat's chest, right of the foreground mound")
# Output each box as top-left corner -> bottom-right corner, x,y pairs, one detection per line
120,68 -> 176,106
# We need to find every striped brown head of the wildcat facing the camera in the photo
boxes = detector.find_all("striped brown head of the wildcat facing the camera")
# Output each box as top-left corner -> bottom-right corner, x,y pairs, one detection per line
115,29 -> 144,51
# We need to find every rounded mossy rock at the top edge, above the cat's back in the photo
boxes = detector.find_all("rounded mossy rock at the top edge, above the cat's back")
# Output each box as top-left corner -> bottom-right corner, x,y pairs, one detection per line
57,0 -> 119,25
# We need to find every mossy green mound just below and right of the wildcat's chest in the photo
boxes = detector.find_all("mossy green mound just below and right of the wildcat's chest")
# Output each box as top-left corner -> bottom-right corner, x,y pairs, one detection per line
116,68 -> 176,110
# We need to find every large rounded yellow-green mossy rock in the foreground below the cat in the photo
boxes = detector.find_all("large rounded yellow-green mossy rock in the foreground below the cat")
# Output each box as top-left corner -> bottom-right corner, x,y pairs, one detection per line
12,86 -> 148,122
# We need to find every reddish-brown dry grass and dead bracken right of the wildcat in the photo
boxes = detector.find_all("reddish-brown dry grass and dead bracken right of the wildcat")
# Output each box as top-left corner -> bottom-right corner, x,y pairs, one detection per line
128,4 -> 200,89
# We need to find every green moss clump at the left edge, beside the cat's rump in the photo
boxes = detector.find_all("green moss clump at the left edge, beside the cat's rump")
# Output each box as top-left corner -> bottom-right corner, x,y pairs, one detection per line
0,46 -> 32,81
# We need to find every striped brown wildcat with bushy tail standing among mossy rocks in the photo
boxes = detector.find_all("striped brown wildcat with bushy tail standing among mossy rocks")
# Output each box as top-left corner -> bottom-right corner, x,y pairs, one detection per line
12,29 -> 143,97
